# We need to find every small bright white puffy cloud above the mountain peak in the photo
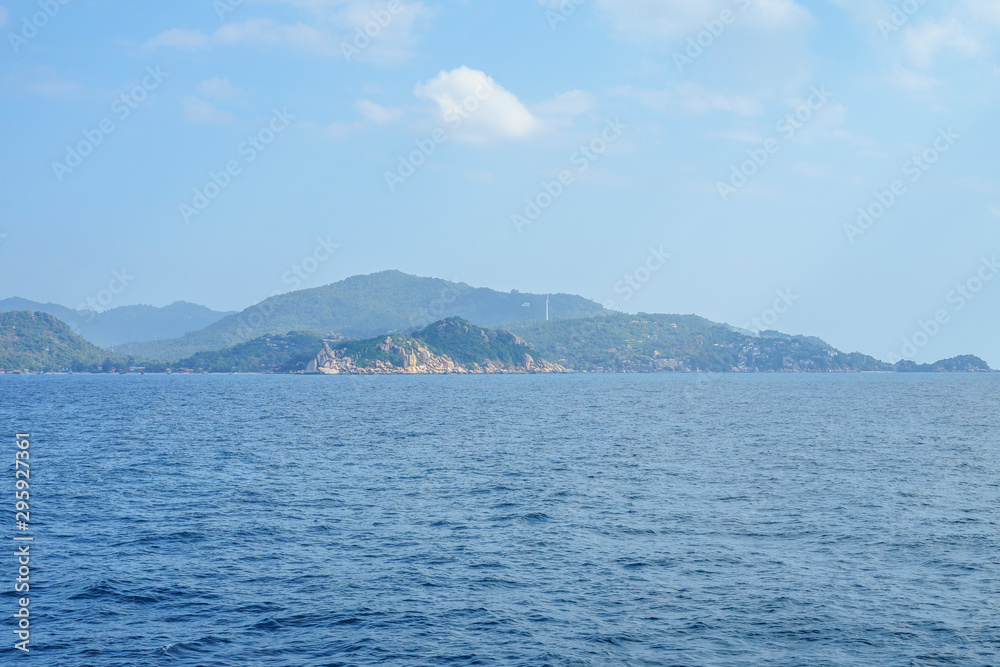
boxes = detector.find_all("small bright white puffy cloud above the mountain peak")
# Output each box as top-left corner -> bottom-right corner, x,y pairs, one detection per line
413,66 -> 542,143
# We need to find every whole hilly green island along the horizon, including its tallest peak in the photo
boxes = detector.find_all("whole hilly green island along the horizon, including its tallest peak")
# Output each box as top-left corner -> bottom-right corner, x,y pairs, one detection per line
0,271 -> 991,375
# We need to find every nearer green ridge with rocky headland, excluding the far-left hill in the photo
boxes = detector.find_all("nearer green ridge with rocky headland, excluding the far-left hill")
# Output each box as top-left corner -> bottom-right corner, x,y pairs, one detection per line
174,314 -> 990,374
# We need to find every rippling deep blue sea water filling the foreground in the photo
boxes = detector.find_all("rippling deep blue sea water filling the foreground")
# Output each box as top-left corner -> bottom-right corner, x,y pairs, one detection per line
0,374 -> 1000,667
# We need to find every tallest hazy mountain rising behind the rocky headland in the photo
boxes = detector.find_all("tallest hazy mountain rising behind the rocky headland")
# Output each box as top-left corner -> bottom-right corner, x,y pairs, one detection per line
116,271 -> 607,360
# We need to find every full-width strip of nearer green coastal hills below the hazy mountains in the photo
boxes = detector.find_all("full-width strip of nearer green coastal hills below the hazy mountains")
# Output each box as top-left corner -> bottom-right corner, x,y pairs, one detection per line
0,311 -> 991,375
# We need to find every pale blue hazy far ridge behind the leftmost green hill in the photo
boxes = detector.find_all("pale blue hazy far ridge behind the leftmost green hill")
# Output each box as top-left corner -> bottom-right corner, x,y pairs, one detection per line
0,297 -> 230,347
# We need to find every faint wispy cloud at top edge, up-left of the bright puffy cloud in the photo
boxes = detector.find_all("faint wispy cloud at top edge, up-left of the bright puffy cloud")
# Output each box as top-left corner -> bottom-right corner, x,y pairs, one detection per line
145,0 -> 430,64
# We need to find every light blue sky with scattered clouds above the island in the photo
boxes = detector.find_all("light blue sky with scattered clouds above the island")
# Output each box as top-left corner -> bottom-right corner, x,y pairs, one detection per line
0,0 -> 1000,367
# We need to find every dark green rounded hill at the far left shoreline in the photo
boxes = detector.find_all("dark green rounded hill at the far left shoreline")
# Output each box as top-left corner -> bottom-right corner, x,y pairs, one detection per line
0,310 -> 108,371
